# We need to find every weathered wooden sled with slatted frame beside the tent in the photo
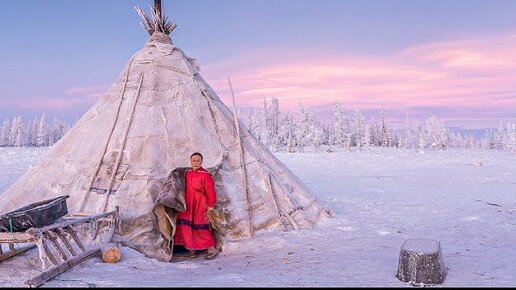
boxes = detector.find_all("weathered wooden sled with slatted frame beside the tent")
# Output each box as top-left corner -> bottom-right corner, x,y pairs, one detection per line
0,207 -> 119,287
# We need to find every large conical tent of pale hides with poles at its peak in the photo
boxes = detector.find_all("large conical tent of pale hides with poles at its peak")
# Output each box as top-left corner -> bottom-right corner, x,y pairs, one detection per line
0,6 -> 329,261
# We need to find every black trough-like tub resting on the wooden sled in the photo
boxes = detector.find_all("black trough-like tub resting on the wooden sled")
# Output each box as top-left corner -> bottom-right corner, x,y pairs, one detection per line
0,195 -> 70,232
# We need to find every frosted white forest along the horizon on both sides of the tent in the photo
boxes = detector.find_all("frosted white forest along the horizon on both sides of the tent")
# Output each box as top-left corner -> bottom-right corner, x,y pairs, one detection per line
0,97 -> 516,153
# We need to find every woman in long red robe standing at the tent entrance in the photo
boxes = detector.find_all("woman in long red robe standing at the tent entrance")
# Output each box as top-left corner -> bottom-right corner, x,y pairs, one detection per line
174,152 -> 219,259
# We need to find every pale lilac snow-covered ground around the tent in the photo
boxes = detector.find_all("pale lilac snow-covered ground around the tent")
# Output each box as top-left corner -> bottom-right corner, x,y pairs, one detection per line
0,148 -> 516,287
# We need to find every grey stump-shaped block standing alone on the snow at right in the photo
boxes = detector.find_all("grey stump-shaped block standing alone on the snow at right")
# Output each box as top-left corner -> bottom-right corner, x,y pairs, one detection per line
396,238 -> 446,285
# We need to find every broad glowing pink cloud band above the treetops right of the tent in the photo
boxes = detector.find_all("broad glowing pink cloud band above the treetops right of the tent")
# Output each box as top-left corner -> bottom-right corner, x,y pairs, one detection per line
203,34 -> 516,123
